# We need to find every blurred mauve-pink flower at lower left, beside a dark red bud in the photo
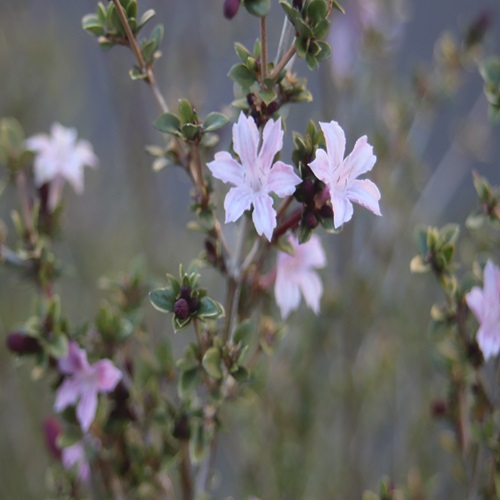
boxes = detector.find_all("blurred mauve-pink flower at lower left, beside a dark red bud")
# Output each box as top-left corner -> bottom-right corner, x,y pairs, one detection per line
54,342 -> 122,431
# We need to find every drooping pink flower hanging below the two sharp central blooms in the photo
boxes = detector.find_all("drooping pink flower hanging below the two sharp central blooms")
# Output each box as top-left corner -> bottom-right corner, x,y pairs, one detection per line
274,235 -> 326,318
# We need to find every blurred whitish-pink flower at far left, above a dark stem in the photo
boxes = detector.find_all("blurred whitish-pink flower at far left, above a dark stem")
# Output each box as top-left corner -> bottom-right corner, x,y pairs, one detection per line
26,123 -> 98,210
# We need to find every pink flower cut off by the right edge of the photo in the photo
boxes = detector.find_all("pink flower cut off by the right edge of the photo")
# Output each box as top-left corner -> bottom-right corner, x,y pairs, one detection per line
465,260 -> 500,359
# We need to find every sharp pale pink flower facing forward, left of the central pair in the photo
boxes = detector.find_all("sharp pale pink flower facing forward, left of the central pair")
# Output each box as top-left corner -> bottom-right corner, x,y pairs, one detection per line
207,113 -> 302,241
